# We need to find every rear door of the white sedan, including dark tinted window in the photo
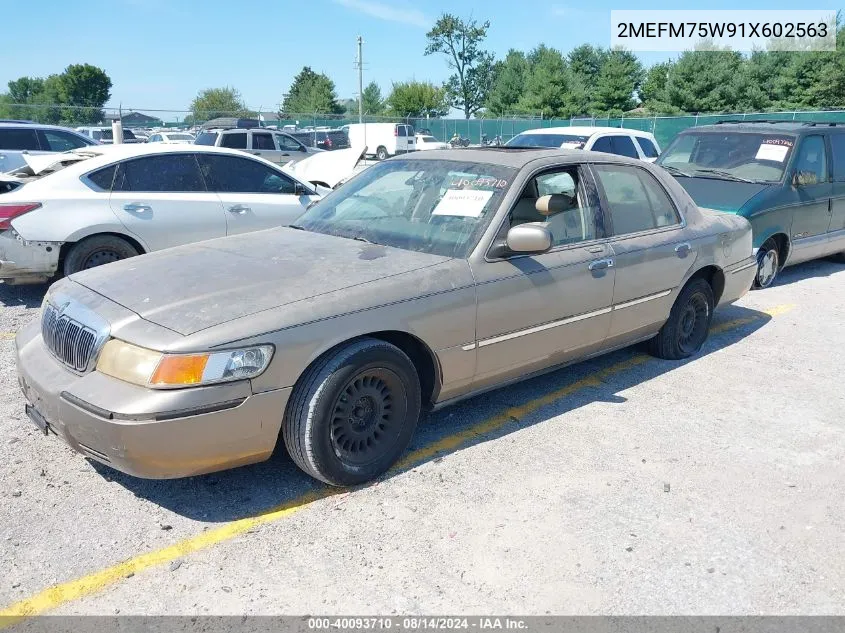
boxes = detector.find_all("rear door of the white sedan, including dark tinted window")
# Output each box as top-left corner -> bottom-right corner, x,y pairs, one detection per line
109,152 -> 226,251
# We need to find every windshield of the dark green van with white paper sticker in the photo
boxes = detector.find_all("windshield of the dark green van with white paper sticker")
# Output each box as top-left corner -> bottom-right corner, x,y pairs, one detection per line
657,130 -> 795,182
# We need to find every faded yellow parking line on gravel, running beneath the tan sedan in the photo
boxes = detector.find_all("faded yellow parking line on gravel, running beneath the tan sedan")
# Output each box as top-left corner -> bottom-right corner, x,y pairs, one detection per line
0,304 -> 795,629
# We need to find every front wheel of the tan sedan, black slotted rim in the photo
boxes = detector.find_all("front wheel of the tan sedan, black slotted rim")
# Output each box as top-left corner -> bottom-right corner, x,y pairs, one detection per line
282,338 -> 421,486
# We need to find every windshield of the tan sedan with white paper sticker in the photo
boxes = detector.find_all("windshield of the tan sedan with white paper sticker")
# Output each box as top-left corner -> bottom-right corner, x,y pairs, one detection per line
296,159 -> 517,257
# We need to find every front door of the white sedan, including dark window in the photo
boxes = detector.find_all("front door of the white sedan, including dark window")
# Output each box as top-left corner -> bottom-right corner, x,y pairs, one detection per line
198,154 -> 319,235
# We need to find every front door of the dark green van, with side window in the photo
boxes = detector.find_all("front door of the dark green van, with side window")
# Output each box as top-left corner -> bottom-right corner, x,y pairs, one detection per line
785,134 -> 832,264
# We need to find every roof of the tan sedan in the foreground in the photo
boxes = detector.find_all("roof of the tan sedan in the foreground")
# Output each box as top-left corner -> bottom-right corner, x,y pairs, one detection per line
396,147 -> 642,169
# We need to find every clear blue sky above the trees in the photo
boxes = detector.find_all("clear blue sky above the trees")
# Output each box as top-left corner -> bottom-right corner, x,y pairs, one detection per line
0,0 -> 837,118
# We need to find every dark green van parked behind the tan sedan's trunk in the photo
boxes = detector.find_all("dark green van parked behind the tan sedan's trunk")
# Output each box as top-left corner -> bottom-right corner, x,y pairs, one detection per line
657,122 -> 845,288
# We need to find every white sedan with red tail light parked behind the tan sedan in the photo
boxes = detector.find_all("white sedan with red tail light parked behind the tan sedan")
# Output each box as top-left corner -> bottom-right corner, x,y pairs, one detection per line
0,143 -> 322,284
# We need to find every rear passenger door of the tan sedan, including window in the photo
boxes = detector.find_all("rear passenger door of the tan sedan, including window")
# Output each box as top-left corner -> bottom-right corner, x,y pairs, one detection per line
593,164 -> 696,345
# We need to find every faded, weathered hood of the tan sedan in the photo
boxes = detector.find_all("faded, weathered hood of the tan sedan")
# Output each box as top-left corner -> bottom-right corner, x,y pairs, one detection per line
70,228 -> 448,336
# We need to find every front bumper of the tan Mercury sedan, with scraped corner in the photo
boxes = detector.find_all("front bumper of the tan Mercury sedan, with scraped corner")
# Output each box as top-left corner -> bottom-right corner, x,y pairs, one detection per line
16,322 -> 291,479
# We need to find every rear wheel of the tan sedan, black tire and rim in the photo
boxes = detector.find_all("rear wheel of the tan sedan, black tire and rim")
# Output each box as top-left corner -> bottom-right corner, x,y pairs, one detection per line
649,279 -> 714,360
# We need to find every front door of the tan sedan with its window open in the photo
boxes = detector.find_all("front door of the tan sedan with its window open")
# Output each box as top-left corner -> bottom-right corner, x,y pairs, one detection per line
472,168 -> 615,388
